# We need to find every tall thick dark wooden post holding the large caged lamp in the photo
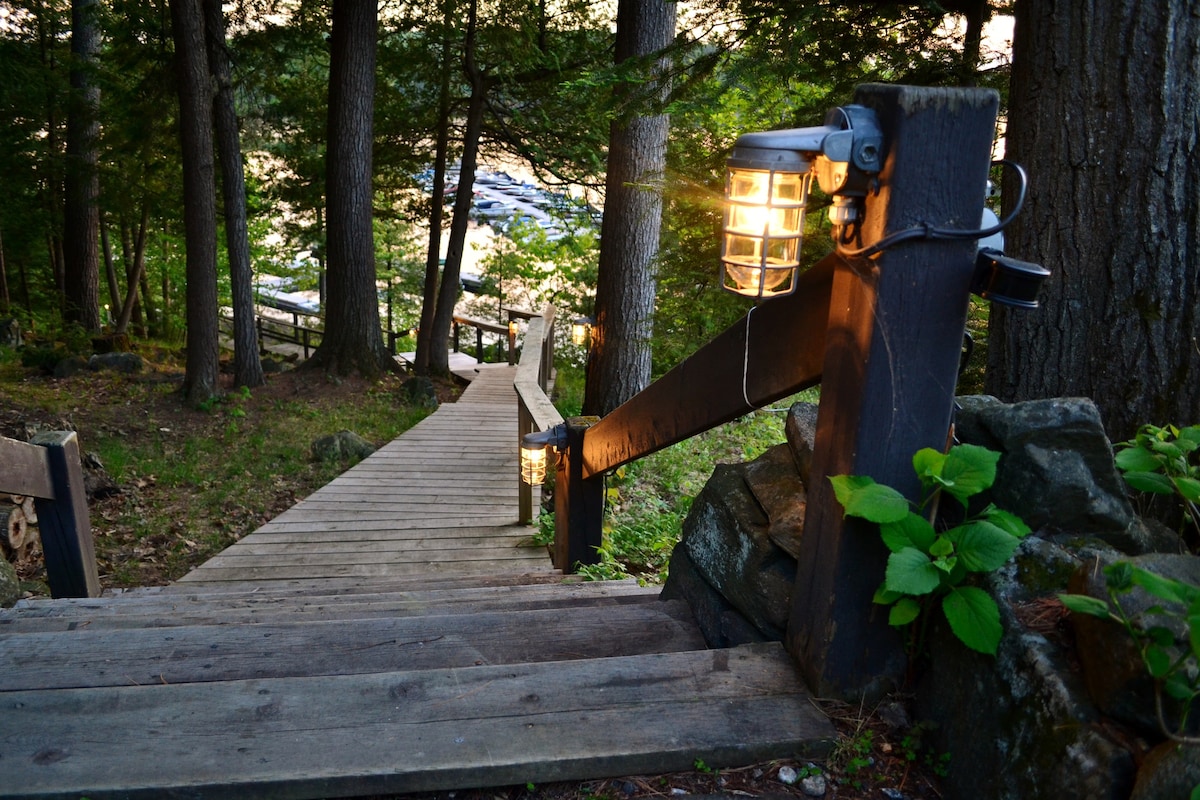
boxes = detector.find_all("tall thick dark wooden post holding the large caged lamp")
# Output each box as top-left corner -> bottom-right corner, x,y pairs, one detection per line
787,85 -> 998,700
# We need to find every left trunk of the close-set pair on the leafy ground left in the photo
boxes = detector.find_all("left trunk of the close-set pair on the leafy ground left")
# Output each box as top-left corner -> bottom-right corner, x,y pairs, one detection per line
170,0 -> 221,404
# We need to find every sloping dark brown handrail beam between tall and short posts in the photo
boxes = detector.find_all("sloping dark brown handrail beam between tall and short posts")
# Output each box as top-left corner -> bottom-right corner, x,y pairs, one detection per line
583,254 -> 842,477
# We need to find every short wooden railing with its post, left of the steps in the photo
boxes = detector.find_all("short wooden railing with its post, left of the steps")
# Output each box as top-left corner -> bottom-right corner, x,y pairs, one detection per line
0,431 -> 100,597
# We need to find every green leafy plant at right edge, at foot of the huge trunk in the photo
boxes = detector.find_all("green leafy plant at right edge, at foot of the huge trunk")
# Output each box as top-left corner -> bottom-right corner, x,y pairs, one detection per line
1116,425 -> 1200,546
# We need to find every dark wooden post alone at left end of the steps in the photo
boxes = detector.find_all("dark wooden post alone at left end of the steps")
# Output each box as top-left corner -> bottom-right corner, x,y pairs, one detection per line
30,431 -> 100,597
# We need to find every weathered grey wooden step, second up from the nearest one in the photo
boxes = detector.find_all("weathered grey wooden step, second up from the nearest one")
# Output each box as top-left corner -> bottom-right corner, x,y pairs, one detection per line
0,601 -> 704,692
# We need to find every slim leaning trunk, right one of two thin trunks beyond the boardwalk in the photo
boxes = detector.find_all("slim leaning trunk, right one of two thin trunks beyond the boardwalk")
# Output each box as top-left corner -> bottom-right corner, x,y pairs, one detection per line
430,0 -> 487,375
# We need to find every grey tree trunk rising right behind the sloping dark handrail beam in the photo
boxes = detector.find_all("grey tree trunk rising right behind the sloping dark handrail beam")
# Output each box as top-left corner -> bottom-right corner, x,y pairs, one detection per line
583,0 -> 676,416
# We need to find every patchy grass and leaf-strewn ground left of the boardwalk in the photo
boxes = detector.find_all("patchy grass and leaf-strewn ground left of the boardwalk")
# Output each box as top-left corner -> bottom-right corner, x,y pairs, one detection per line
0,345 -> 441,587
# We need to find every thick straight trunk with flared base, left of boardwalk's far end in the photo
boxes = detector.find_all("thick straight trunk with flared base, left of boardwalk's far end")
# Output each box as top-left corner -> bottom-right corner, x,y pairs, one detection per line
305,0 -> 396,377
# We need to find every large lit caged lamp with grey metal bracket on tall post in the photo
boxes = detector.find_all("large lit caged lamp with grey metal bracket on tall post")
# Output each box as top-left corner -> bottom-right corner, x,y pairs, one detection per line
721,106 -> 883,300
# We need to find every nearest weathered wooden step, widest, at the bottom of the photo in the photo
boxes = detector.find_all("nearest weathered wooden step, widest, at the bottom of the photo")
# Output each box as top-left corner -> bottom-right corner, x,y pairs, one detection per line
0,644 -> 834,800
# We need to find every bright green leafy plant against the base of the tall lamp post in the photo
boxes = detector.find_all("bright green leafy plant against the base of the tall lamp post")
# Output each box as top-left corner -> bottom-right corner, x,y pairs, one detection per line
829,445 -> 1030,655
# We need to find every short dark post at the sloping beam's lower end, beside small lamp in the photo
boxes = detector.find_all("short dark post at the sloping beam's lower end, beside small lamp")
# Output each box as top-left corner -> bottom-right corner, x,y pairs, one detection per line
554,416 -> 604,572
